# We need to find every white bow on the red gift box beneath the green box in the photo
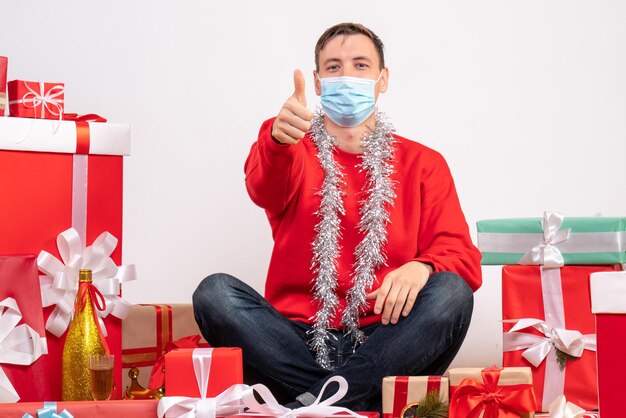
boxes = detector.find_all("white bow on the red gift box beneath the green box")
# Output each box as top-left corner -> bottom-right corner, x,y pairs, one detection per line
504,318 -> 596,367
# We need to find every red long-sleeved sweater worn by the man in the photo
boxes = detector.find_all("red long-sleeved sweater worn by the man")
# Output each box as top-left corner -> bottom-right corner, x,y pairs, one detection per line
245,119 -> 482,328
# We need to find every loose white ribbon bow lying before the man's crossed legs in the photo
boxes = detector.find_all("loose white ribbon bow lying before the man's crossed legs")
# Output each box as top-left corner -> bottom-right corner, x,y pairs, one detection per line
243,376 -> 365,418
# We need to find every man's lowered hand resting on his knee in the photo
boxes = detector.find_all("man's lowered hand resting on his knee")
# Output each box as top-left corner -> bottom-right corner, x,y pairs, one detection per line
366,261 -> 433,325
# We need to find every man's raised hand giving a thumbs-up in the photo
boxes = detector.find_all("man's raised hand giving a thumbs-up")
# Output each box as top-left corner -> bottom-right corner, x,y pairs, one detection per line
272,70 -> 313,144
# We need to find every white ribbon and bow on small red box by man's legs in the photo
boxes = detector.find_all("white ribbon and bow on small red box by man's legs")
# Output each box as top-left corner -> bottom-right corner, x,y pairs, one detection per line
157,348 -> 248,418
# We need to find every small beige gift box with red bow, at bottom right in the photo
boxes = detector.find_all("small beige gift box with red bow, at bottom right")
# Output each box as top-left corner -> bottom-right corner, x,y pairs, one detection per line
448,367 -> 536,418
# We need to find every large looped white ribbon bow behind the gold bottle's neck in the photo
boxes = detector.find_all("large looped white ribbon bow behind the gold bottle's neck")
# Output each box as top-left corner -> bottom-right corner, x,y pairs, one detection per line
37,228 -> 136,337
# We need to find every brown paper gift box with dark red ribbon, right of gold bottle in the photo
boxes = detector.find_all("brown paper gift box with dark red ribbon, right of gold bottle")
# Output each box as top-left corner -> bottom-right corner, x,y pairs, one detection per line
122,304 -> 208,389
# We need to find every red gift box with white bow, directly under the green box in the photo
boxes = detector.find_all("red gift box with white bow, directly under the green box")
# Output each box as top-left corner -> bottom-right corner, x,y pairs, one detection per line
502,266 -> 614,411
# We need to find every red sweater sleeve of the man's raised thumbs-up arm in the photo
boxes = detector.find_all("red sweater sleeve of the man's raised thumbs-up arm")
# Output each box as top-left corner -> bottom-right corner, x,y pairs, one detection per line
244,118 -> 305,218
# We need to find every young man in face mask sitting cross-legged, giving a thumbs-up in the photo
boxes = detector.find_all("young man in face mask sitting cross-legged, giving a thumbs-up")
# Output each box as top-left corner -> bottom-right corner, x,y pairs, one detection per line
193,23 -> 481,410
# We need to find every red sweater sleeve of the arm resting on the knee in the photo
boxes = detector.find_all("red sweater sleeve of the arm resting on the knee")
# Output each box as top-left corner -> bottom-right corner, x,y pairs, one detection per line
415,153 -> 482,290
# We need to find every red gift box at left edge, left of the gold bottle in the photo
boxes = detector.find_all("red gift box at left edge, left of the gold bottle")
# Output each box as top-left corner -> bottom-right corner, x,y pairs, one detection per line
0,255 -> 51,402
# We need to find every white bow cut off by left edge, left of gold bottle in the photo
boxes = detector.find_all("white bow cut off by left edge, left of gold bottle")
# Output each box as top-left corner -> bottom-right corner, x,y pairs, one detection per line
0,298 -> 47,402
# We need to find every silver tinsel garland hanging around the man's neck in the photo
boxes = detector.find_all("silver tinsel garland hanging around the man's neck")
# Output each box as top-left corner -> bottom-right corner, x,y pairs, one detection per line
311,110 -> 396,370
